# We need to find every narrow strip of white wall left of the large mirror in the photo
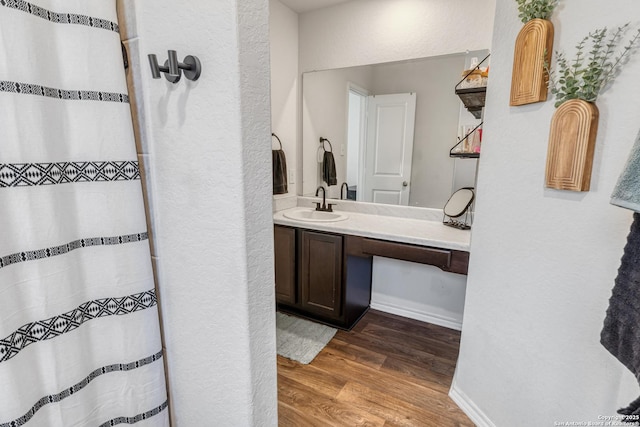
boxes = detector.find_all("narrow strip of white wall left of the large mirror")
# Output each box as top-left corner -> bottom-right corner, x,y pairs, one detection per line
269,0 -> 299,197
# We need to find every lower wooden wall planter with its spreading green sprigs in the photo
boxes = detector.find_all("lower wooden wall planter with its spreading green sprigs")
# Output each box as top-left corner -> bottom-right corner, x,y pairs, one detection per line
545,24 -> 640,191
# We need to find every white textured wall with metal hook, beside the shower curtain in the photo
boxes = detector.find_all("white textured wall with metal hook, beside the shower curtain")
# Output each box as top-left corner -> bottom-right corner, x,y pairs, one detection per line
120,0 -> 277,426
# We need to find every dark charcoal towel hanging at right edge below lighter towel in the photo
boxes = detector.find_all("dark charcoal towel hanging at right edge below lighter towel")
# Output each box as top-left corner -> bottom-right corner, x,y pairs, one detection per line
600,212 -> 640,415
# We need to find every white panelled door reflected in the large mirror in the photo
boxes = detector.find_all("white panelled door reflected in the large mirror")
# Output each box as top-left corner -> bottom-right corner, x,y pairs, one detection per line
358,93 -> 416,205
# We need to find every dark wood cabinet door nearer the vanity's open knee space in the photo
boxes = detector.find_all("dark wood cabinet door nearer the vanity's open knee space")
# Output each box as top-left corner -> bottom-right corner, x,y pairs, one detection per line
300,231 -> 342,318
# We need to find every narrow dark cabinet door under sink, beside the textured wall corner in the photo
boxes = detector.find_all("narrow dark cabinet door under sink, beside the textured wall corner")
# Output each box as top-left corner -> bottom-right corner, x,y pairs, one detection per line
273,225 -> 296,305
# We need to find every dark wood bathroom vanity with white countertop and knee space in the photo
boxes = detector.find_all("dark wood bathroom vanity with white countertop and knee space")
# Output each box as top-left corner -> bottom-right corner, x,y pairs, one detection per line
274,208 -> 469,330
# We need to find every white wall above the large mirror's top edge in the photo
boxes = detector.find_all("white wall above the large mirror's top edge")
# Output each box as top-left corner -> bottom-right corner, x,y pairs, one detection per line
299,0 -> 495,72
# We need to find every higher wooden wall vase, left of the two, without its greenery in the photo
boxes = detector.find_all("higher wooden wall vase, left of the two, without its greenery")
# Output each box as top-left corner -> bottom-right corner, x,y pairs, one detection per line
509,19 -> 553,106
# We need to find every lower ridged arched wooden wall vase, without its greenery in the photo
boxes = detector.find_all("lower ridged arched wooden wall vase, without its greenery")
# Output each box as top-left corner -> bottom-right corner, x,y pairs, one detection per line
546,99 -> 599,191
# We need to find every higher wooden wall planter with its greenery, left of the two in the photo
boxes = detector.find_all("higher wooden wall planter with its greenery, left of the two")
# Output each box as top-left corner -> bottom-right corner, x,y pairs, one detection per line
509,0 -> 558,106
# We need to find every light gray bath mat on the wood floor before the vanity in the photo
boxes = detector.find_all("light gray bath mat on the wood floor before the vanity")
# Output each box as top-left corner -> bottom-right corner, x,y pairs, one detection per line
276,313 -> 337,365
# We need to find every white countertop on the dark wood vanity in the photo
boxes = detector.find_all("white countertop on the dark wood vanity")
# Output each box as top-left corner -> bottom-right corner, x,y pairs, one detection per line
273,207 -> 471,252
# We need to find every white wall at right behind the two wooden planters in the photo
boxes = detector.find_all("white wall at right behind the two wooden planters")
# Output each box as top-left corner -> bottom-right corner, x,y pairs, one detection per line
452,0 -> 640,427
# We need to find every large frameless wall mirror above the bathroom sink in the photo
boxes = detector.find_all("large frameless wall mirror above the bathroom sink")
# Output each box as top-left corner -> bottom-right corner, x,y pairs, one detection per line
302,50 -> 488,209
